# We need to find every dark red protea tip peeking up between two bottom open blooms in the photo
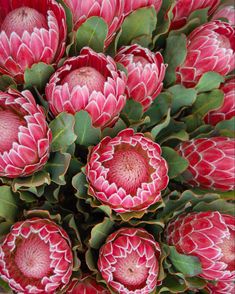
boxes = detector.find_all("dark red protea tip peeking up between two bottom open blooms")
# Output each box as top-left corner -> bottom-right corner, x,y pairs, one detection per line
66,276 -> 110,294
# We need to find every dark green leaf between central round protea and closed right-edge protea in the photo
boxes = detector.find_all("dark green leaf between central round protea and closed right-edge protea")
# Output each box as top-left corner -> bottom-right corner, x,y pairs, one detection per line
162,147 -> 188,179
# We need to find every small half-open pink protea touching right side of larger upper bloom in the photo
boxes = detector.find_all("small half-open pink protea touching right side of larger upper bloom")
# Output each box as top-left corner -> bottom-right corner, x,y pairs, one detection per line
115,45 -> 166,111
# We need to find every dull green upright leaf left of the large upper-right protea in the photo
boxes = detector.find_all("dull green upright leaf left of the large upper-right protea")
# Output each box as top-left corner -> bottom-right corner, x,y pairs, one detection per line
164,34 -> 187,86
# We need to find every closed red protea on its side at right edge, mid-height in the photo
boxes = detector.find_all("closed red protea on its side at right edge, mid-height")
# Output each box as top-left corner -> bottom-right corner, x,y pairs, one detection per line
178,137 -> 235,191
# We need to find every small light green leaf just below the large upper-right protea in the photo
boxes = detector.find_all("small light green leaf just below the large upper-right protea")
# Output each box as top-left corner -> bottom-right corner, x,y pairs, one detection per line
195,71 -> 224,93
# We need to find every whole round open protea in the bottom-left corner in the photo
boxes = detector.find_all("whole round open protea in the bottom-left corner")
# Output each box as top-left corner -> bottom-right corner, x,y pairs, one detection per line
0,218 -> 73,294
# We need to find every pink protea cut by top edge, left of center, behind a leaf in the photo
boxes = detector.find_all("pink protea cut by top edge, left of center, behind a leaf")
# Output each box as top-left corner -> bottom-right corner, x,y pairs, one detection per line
64,0 -> 124,47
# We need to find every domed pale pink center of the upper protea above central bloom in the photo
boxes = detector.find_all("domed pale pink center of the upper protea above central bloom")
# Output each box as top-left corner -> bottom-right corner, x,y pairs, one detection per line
62,66 -> 105,93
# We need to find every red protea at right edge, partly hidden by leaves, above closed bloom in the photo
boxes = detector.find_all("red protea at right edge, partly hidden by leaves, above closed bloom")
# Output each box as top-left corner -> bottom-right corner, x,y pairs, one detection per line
204,78 -> 235,126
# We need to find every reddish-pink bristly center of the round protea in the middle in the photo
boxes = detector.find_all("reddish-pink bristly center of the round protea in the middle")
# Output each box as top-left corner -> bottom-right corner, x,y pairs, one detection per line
104,150 -> 149,195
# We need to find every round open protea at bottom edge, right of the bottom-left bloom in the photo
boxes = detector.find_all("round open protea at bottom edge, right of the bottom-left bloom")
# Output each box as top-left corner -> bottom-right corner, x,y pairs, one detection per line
98,228 -> 161,294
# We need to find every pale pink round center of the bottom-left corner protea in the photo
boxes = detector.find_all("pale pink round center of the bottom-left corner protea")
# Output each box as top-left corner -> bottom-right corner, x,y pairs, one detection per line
15,235 -> 51,279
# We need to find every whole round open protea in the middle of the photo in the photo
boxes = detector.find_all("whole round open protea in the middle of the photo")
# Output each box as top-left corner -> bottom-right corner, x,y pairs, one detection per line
86,129 -> 168,213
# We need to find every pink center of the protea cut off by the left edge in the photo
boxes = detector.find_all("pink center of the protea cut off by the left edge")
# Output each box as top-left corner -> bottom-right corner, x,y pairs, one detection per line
0,109 -> 25,152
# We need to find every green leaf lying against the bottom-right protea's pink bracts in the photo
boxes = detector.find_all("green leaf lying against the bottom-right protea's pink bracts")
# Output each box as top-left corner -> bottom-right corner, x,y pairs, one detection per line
169,246 -> 202,277
